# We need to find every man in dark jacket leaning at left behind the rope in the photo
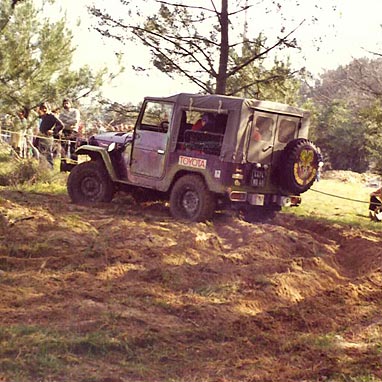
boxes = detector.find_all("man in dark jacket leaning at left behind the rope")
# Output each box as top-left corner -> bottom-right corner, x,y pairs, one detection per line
36,102 -> 64,168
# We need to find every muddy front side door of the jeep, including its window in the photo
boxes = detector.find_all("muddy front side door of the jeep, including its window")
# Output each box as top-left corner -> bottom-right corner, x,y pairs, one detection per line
131,101 -> 173,178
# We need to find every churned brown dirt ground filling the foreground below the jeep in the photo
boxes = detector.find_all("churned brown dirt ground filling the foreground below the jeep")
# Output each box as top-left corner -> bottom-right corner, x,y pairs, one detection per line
0,191 -> 382,382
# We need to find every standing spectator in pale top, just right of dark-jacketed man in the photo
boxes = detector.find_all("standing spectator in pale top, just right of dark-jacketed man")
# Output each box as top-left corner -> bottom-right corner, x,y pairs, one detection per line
59,98 -> 81,160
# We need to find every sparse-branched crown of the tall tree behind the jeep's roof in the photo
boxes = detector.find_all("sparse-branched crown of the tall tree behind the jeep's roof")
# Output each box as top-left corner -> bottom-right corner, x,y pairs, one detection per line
91,0 -> 334,94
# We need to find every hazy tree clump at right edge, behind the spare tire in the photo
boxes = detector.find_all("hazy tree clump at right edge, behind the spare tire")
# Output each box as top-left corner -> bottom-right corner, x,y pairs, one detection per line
309,58 -> 382,173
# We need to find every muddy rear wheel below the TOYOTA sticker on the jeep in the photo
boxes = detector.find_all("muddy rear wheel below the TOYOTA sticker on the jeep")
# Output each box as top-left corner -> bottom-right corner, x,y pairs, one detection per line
170,175 -> 216,222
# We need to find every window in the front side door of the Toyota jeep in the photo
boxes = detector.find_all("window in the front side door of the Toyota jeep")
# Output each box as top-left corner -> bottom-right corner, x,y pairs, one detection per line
138,101 -> 173,133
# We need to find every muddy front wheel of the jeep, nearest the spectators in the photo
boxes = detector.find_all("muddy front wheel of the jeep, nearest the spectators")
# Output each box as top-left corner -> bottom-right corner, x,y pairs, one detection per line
67,161 -> 114,203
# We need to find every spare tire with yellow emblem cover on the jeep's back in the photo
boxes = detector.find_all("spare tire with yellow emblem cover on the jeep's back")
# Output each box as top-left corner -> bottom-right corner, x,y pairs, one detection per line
277,138 -> 318,194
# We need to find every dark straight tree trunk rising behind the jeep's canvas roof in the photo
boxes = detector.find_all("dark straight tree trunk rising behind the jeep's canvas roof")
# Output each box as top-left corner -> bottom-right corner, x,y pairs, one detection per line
215,0 -> 229,94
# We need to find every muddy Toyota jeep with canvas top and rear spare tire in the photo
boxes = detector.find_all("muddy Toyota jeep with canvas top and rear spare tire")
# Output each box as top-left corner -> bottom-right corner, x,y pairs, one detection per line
67,93 -> 318,221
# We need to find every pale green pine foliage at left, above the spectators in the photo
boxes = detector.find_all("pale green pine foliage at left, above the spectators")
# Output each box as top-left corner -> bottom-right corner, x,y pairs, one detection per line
0,0 -> 105,112
